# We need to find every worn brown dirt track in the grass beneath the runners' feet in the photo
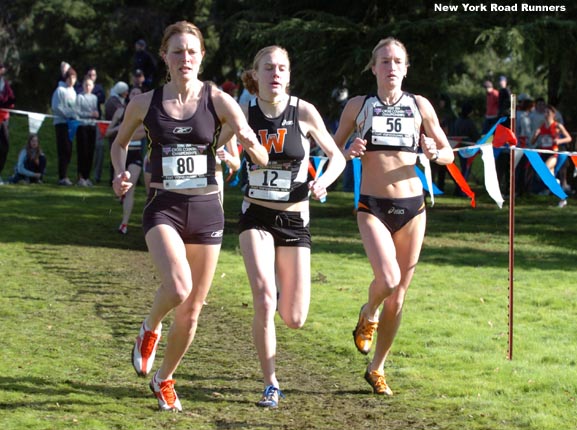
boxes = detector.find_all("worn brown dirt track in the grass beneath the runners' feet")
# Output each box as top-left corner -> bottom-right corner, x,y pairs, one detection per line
29,246 -> 437,430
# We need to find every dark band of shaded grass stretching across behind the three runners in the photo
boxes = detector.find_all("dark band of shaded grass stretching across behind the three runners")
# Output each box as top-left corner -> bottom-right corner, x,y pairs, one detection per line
0,185 -> 577,270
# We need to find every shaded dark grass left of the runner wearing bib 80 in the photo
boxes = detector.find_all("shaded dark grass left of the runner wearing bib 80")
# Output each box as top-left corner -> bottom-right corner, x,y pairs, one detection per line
0,184 -> 146,250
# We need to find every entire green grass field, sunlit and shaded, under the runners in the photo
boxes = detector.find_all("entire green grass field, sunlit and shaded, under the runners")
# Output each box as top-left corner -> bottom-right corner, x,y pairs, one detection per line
0,117 -> 577,430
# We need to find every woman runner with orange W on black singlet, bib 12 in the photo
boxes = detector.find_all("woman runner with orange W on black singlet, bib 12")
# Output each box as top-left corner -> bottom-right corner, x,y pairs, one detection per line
239,46 -> 345,408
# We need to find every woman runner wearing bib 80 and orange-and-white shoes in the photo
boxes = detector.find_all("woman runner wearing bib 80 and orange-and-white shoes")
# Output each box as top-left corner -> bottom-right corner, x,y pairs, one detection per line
111,21 -> 268,411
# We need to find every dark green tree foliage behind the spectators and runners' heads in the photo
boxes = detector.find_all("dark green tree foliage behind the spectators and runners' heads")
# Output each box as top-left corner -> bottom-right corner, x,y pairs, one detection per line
0,0 -> 577,130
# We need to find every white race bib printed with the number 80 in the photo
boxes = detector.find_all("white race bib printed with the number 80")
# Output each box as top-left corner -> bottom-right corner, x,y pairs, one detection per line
162,143 -> 208,190
